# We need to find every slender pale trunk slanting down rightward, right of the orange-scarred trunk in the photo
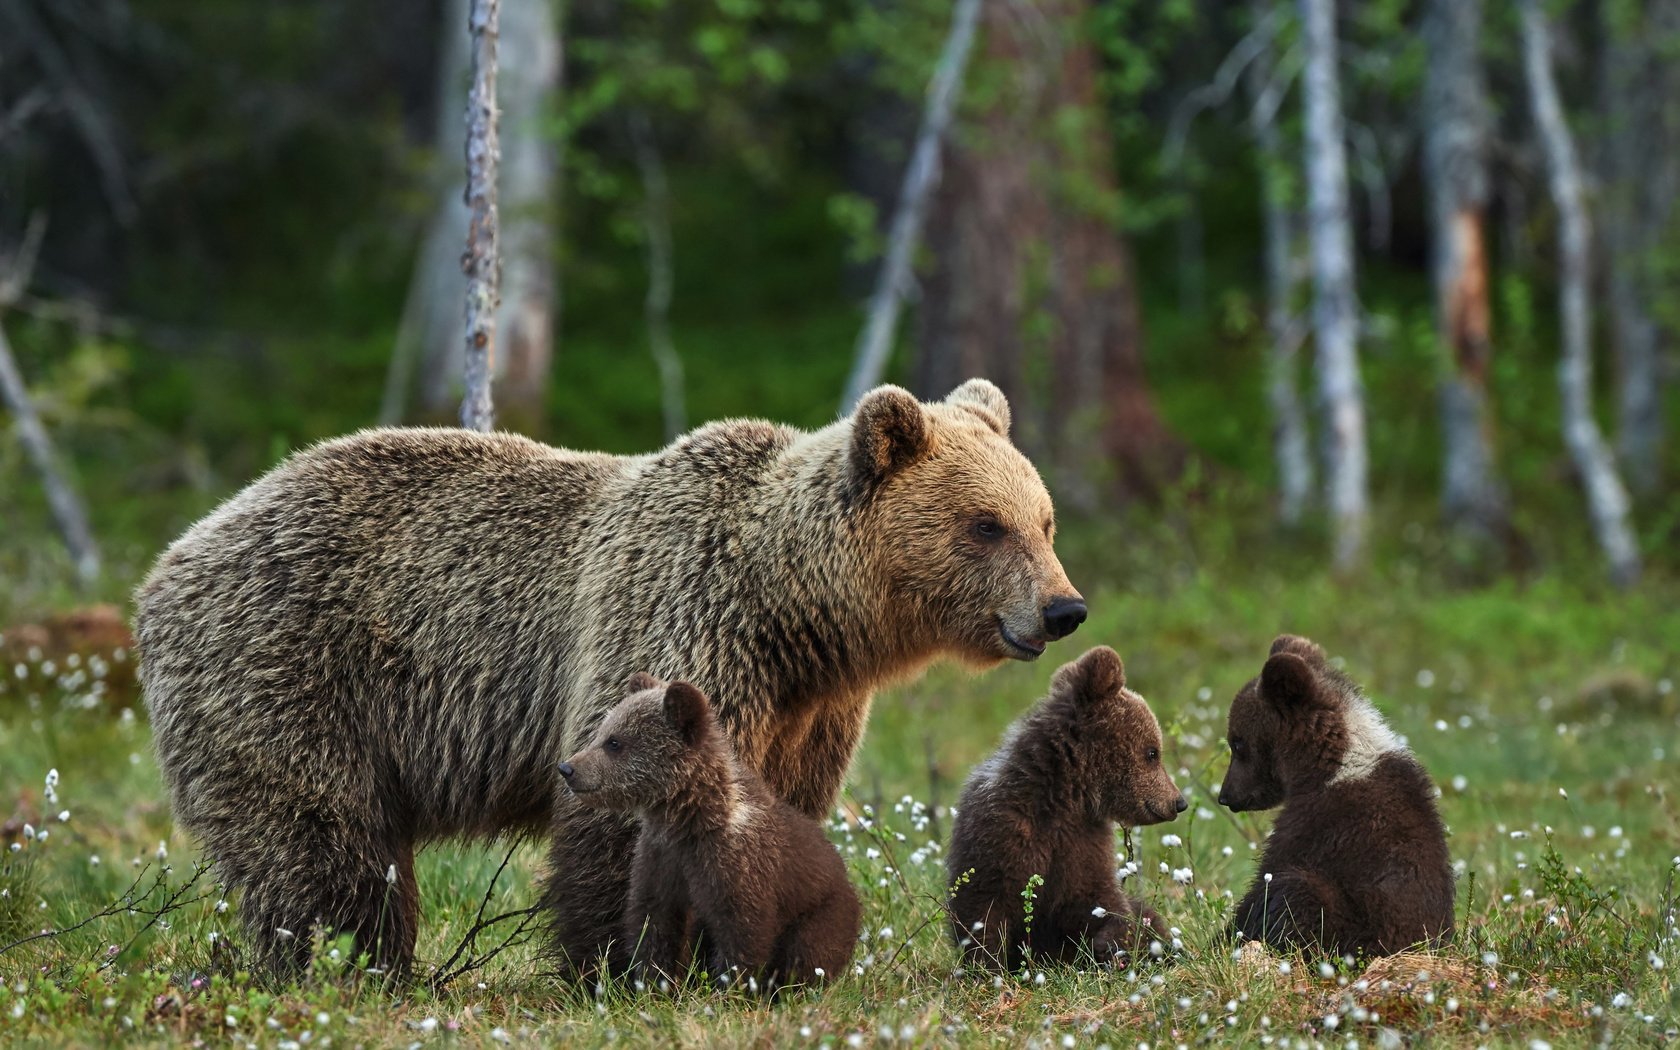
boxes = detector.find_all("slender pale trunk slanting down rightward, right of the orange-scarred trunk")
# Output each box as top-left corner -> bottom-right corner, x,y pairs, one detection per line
1519,0 -> 1640,585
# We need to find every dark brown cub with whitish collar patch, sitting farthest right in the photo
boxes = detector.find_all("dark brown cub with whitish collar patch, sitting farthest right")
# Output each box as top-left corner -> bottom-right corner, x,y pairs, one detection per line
1220,635 -> 1453,956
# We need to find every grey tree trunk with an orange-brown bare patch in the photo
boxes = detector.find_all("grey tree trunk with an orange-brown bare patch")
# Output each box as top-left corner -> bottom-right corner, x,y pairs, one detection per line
1423,0 -> 1509,539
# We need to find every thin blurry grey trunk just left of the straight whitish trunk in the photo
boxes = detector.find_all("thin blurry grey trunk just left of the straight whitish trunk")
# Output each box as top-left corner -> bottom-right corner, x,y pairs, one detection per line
1247,0 -> 1312,526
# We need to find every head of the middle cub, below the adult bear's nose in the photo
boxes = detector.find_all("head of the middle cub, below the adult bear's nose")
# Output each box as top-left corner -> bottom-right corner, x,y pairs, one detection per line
1050,645 -> 1189,827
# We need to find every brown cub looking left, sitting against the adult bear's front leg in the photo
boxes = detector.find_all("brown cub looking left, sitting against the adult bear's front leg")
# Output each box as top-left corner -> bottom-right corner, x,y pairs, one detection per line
559,674 -> 860,990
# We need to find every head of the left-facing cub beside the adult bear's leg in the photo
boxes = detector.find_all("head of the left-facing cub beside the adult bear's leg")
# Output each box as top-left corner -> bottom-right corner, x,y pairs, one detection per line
559,672 -> 714,811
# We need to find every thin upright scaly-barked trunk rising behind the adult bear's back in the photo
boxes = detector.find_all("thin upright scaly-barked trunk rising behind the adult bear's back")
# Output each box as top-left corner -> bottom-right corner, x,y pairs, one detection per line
460,0 -> 501,430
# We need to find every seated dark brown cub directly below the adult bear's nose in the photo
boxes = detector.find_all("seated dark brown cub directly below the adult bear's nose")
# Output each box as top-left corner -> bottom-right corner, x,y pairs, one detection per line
949,645 -> 1186,971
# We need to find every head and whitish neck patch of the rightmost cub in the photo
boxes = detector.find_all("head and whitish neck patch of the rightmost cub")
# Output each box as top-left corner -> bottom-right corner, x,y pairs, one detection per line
1220,635 -> 1401,811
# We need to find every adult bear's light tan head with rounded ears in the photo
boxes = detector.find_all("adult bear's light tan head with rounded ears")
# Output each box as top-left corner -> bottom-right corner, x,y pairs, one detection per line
847,380 -> 1085,665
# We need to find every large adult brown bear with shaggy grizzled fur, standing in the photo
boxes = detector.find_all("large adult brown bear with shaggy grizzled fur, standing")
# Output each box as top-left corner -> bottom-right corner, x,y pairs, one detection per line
136,380 -> 1084,969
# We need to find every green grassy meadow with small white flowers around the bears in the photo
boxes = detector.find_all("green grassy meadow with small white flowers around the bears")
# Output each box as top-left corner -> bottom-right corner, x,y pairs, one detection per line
0,506 -> 1680,1047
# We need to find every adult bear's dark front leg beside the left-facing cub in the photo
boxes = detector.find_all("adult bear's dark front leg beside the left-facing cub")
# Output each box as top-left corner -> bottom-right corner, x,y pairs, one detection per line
543,795 -> 637,979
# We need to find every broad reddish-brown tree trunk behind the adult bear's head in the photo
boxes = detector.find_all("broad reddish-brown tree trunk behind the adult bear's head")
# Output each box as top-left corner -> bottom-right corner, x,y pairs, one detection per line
917,0 -> 1184,509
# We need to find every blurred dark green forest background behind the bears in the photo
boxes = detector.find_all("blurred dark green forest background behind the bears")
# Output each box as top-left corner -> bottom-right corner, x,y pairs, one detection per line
0,0 -> 1680,604
